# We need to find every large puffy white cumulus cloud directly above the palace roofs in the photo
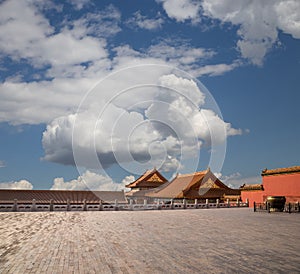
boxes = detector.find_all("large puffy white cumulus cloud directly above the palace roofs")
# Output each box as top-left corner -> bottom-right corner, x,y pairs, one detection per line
43,71 -> 241,170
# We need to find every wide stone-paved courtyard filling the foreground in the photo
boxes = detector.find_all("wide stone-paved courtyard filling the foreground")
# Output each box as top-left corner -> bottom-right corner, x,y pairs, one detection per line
0,208 -> 300,273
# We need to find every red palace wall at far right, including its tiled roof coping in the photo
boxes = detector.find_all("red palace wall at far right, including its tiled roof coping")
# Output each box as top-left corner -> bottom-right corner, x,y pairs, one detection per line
240,166 -> 300,206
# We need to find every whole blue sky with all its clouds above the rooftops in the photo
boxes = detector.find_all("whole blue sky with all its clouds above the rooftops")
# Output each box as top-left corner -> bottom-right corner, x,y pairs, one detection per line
0,0 -> 300,190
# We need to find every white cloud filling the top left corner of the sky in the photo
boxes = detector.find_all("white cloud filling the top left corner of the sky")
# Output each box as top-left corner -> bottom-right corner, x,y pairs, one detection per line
0,0 -> 108,71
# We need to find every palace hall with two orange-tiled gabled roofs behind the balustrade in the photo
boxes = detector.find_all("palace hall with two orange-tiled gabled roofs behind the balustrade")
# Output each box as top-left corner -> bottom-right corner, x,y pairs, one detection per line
126,168 -> 240,202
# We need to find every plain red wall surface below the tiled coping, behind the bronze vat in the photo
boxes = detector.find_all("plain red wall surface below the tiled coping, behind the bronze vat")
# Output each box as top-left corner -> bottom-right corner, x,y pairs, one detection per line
241,173 -> 300,207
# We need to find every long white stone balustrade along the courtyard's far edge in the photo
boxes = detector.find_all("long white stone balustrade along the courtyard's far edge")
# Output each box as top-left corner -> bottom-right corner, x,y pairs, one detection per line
0,200 -> 249,212
